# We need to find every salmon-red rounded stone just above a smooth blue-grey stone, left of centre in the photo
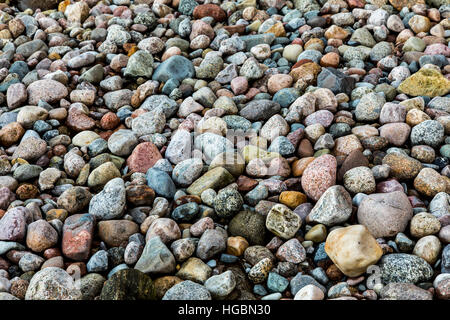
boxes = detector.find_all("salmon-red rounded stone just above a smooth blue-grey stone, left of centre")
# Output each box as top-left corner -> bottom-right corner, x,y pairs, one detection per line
127,142 -> 162,173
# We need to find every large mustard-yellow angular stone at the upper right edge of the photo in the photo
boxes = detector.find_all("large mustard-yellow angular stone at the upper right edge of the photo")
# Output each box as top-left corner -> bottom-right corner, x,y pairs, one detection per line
397,68 -> 450,97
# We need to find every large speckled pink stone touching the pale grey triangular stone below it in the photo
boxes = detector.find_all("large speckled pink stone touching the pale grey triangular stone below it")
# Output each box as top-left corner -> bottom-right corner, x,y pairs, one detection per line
302,154 -> 337,201
